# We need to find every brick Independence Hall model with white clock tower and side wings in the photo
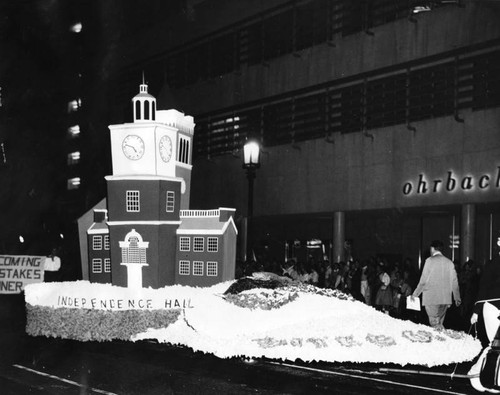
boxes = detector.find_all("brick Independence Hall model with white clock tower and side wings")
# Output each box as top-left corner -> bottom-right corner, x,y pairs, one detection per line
82,83 -> 237,288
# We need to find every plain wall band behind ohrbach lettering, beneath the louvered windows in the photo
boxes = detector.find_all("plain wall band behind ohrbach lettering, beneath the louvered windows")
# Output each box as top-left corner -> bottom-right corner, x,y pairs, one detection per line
192,109 -> 500,216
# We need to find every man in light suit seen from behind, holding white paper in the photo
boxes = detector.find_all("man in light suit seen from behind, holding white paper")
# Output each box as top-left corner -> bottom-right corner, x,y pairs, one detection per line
411,240 -> 461,329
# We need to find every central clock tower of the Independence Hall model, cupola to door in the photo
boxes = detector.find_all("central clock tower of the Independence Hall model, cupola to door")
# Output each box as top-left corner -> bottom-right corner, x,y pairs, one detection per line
106,82 -> 194,288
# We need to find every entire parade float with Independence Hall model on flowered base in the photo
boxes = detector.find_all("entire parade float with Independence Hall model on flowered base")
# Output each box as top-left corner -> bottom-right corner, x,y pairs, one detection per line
24,83 -> 481,366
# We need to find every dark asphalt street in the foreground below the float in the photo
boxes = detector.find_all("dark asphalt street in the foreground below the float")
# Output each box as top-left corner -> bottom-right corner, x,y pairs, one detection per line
0,295 -> 480,394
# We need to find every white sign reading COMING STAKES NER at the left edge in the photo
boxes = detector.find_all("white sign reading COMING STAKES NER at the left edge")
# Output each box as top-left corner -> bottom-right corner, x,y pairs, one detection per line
0,255 -> 45,294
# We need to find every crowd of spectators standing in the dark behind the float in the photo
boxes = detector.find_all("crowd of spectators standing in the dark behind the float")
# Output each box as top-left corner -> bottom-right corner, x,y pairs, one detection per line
240,257 -> 481,329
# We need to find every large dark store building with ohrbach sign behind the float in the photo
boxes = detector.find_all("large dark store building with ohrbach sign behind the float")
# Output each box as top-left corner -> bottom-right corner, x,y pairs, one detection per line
92,0 -> 500,265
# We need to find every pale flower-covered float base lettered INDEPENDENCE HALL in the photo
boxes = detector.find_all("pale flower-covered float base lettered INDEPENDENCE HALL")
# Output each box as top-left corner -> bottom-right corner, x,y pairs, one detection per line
25,281 -> 481,367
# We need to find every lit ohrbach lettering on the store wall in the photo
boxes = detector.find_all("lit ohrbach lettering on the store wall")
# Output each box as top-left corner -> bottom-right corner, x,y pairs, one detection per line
403,166 -> 500,196
